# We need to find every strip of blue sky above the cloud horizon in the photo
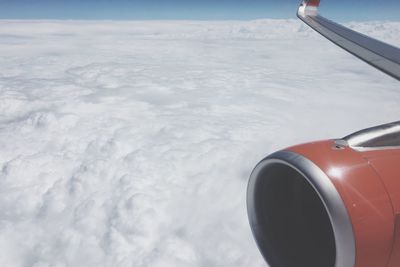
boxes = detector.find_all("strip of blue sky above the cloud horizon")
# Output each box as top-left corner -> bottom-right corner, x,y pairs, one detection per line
0,0 -> 400,21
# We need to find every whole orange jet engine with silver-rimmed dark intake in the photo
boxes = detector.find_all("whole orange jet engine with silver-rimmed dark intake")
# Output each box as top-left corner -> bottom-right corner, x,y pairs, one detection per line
247,122 -> 400,267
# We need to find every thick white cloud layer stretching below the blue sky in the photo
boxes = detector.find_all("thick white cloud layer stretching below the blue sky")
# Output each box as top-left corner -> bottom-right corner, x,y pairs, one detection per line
0,20 -> 400,267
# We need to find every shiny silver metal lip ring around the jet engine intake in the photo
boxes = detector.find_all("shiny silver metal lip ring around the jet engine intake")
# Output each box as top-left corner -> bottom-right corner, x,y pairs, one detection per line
247,151 -> 356,267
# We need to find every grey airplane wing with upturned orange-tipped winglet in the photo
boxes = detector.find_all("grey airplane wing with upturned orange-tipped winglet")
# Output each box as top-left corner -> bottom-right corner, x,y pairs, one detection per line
297,0 -> 400,80
